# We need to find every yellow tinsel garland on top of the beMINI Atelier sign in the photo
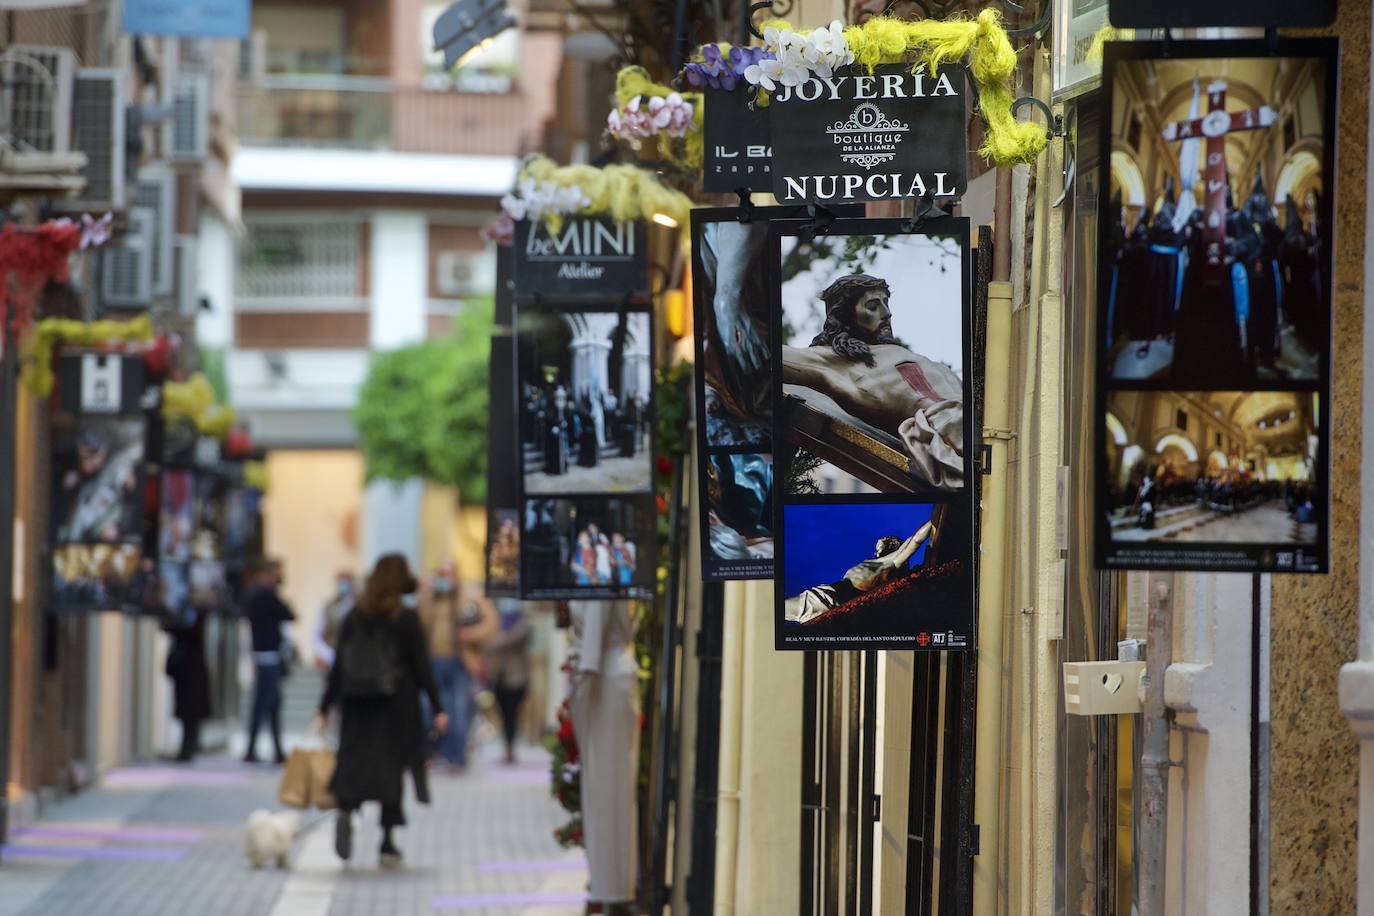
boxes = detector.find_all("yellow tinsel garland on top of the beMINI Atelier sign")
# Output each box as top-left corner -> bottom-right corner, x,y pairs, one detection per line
519,155 -> 691,232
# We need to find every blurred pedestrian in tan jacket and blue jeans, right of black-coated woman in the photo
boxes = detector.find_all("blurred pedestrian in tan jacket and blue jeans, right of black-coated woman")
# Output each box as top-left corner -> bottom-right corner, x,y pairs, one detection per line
419,560 -> 500,773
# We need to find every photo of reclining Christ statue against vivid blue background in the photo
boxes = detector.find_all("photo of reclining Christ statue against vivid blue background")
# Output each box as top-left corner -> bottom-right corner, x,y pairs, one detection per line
776,503 -> 973,648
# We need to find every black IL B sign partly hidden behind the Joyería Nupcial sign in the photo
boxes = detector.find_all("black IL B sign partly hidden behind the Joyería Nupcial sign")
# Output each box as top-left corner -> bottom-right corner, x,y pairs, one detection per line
701,88 -> 772,194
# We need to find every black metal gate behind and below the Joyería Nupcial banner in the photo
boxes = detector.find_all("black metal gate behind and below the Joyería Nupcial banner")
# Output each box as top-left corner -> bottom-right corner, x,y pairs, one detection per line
800,227 -> 992,916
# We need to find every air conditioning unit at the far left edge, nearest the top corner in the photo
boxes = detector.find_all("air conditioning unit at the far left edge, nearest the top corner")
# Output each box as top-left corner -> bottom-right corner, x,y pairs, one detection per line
0,44 -> 77,154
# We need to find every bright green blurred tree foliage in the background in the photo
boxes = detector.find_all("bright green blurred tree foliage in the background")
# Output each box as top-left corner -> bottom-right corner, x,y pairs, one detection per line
353,301 -> 492,504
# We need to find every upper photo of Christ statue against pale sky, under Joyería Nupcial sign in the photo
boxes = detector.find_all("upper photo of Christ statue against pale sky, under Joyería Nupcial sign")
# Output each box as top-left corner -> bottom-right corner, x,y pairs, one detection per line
779,232 -> 967,496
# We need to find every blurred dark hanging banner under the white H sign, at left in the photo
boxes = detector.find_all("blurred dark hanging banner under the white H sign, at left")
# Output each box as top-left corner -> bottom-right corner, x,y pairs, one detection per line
52,354 -> 147,611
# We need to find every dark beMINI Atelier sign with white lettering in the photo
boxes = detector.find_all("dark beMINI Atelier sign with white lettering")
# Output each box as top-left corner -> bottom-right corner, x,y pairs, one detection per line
513,218 -> 649,299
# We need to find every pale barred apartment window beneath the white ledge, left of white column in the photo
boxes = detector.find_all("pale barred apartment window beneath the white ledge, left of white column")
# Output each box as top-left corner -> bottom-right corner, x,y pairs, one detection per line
236,218 -> 367,299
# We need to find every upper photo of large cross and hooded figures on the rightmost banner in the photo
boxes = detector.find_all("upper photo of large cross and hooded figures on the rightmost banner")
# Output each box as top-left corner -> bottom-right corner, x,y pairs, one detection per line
1102,58 -> 1330,389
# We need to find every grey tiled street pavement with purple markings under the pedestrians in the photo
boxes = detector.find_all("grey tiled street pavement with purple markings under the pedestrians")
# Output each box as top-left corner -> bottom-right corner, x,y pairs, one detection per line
0,748 -> 587,916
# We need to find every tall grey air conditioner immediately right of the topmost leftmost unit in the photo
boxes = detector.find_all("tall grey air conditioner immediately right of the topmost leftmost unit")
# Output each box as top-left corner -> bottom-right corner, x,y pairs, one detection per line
70,67 -> 126,210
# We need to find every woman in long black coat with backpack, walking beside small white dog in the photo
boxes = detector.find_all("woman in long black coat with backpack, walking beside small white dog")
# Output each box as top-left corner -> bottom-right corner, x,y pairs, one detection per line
319,553 -> 448,865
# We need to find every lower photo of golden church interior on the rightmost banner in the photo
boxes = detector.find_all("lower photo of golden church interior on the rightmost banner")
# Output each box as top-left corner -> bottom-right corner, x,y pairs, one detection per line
1105,391 -> 1323,544
